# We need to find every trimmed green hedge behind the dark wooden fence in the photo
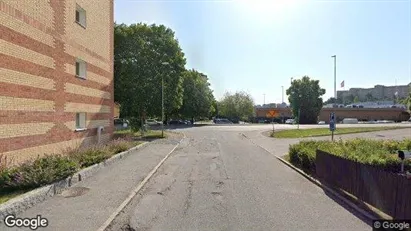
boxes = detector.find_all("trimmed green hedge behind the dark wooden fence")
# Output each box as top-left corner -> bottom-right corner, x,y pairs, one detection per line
289,139 -> 411,173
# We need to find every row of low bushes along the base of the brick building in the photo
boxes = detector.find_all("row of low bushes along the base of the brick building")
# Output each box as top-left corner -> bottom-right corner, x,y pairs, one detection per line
0,140 -> 137,193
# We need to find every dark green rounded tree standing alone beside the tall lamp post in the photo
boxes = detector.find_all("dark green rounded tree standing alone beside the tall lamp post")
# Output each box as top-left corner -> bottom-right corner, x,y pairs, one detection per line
286,76 -> 325,124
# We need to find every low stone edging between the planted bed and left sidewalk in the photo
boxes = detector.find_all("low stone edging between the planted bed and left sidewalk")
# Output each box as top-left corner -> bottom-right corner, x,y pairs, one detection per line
0,142 -> 148,224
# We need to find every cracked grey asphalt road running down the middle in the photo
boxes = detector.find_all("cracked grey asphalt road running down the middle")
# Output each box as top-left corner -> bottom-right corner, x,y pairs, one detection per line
104,125 -> 411,231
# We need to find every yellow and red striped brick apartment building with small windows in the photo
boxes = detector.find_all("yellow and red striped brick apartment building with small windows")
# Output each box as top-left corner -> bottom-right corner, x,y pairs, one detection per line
0,0 -> 114,162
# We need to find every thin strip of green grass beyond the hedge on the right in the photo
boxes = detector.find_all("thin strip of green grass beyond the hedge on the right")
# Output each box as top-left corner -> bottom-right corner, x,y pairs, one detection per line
270,127 -> 405,138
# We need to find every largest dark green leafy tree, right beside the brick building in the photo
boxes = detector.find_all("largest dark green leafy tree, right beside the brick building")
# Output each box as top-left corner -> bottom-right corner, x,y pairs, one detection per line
114,23 -> 186,127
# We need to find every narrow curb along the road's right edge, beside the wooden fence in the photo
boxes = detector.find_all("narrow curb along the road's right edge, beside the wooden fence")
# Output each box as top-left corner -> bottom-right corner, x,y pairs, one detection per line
242,134 -> 380,220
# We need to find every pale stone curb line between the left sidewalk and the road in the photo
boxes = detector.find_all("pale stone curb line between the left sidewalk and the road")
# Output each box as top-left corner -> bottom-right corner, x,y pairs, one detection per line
97,133 -> 186,231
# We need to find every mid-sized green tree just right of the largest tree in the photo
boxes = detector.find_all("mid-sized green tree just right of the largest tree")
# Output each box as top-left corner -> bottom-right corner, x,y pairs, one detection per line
180,69 -> 215,121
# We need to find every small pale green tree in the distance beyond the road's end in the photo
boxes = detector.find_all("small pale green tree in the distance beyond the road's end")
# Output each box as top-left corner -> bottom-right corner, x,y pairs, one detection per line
217,91 -> 254,120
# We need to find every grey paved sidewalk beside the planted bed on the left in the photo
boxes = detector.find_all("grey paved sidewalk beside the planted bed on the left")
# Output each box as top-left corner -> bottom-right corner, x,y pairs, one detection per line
0,139 -> 182,231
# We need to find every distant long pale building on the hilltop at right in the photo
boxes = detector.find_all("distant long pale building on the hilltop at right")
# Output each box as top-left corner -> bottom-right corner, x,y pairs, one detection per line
337,83 -> 411,101
